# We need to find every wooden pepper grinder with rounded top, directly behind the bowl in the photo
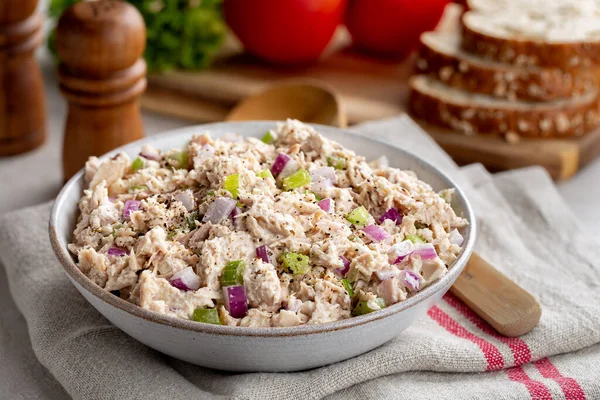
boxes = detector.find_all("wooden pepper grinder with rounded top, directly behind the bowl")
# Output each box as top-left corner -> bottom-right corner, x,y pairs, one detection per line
56,0 -> 146,179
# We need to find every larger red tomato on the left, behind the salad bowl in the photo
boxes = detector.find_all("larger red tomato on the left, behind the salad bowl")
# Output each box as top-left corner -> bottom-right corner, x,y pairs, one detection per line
223,0 -> 346,64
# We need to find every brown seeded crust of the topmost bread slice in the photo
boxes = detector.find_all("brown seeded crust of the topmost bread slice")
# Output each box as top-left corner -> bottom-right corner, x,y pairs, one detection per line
461,11 -> 600,70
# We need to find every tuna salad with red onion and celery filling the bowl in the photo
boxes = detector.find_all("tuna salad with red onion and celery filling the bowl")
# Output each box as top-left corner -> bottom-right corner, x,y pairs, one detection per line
69,120 -> 467,327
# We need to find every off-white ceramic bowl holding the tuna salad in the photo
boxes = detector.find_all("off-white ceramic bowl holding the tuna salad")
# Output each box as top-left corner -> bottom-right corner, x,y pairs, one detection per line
49,121 -> 475,371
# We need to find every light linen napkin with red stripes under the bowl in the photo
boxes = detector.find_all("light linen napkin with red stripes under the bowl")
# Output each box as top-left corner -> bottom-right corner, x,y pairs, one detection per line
0,117 -> 600,399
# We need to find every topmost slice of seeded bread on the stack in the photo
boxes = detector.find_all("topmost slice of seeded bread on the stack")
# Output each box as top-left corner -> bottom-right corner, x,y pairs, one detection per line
461,8 -> 600,69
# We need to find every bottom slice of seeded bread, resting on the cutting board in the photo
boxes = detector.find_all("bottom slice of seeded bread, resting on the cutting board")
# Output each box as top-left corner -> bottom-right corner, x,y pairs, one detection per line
409,75 -> 600,138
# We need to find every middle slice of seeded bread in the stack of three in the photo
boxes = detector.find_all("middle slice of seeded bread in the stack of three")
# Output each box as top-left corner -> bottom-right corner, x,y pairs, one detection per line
416,32 -> 600,100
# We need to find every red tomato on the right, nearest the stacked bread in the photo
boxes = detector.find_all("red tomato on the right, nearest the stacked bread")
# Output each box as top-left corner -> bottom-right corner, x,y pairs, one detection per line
345,0 -> 450,57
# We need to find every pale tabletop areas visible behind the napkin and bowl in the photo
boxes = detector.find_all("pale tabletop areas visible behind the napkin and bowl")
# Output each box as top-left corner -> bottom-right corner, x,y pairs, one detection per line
0,54 -> 600,238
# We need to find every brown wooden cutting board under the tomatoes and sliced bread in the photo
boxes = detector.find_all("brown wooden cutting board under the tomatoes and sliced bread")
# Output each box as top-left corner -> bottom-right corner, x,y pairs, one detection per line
142,7 -> 600,179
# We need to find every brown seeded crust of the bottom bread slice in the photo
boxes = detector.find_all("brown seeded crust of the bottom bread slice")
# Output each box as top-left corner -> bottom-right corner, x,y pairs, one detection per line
409,76 -> 600,138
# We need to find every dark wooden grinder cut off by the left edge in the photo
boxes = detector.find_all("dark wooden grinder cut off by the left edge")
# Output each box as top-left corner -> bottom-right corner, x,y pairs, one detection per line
0,0 -> 46,156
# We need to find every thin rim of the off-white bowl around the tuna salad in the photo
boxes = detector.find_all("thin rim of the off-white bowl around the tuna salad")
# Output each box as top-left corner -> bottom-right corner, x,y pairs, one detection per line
48,121 -> 477,338
